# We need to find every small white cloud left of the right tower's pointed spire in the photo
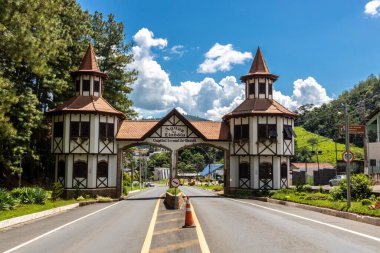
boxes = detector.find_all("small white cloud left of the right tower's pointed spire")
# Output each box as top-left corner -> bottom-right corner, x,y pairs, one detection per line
197,43 -> 252,73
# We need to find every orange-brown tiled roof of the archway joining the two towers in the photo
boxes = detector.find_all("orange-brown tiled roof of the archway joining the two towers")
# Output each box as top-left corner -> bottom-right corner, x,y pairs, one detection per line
116,109 -> 230,141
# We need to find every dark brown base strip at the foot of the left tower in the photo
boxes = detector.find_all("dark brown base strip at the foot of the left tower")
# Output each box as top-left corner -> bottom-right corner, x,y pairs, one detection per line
62,187 -> 120,199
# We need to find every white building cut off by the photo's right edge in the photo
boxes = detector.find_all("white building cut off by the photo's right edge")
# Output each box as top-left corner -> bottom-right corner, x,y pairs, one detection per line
366,107 -> 380,183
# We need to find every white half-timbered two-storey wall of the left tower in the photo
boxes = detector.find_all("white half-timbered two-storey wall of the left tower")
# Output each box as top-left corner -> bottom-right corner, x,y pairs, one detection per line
51,113 -> 119,189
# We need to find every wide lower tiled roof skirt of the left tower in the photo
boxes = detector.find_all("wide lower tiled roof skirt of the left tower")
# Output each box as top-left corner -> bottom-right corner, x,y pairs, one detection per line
48,96 -> 125,118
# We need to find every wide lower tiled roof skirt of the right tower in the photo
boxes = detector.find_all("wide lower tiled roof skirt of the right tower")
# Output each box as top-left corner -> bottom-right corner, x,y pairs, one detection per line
223,98 -> 297,119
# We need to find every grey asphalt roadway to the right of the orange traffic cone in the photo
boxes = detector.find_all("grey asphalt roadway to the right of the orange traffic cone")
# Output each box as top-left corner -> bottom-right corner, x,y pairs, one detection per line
182,187 -> 380,253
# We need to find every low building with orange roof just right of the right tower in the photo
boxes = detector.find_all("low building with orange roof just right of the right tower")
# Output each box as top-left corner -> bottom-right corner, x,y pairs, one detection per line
290,163 -> 336,185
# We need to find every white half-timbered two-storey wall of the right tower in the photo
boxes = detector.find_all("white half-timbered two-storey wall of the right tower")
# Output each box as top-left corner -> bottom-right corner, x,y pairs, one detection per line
230,113 -> 295,190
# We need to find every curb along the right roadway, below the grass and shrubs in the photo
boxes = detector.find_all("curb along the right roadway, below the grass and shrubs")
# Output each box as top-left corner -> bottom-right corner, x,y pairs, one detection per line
223,194 -> 380,226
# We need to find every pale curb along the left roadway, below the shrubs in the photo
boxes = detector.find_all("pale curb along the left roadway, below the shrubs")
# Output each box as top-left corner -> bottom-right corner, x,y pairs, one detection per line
0,199 -> 119,229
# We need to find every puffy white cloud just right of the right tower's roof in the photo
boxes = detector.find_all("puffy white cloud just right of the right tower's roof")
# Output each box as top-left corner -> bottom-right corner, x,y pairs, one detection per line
273,77 -> 332,110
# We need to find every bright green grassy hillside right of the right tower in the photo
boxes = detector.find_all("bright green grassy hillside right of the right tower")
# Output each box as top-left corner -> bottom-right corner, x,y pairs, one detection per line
293,127 -> 364,165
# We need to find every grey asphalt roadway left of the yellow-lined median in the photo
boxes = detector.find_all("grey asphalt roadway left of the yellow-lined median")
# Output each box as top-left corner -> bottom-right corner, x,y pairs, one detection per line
0,187 -> 166,253
